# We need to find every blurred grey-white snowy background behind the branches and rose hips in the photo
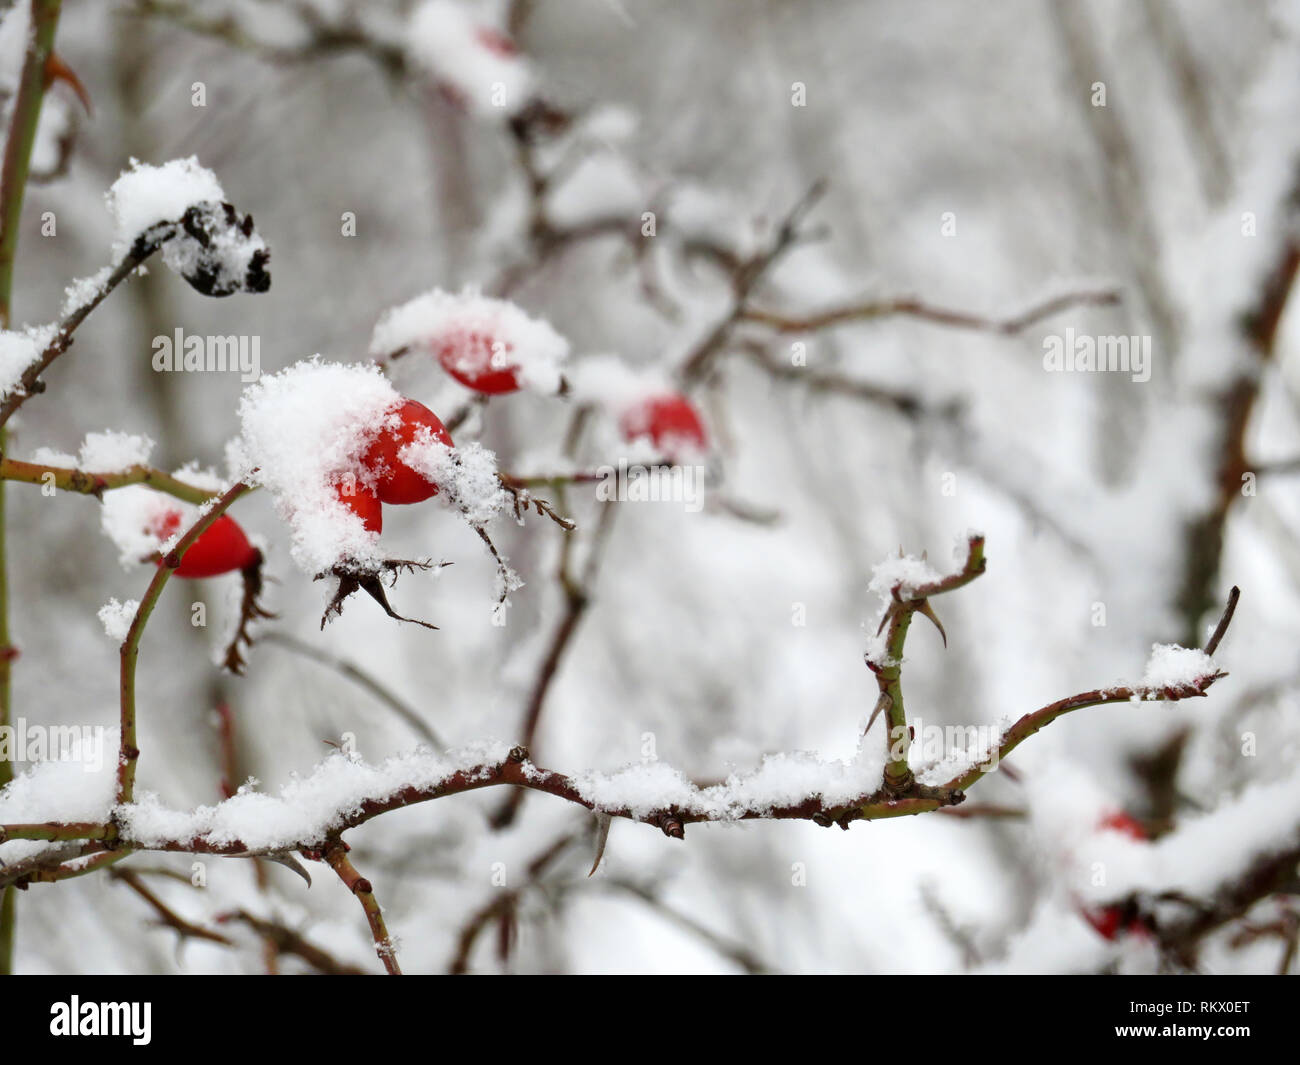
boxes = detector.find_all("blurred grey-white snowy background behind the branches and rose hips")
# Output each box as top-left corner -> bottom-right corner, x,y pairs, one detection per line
0,0 -> 1300,973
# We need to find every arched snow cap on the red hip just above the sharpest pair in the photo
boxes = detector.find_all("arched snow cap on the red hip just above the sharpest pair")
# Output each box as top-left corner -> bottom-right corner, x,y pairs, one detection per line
371,286 -> 569,393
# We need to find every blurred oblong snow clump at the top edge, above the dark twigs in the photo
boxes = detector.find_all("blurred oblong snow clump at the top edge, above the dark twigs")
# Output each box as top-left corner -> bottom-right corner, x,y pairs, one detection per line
406,0 -> 533,118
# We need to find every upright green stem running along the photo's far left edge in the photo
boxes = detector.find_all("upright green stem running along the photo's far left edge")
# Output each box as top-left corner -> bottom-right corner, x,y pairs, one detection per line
0,0 -> 61,975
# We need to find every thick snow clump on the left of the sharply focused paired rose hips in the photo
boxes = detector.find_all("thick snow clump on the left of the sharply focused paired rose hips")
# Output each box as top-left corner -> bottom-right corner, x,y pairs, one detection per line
229,355 -> 402,576
